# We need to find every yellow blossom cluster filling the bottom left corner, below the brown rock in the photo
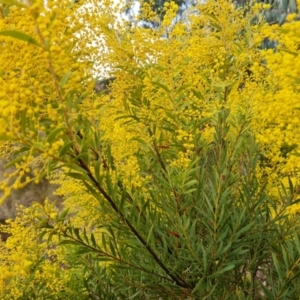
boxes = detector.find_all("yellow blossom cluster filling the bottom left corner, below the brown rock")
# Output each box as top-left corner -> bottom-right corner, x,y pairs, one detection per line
0,202 -> 71,299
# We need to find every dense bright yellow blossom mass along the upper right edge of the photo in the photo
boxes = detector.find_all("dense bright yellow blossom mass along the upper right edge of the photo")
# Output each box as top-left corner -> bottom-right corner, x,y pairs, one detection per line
257,15 -> 300,180
